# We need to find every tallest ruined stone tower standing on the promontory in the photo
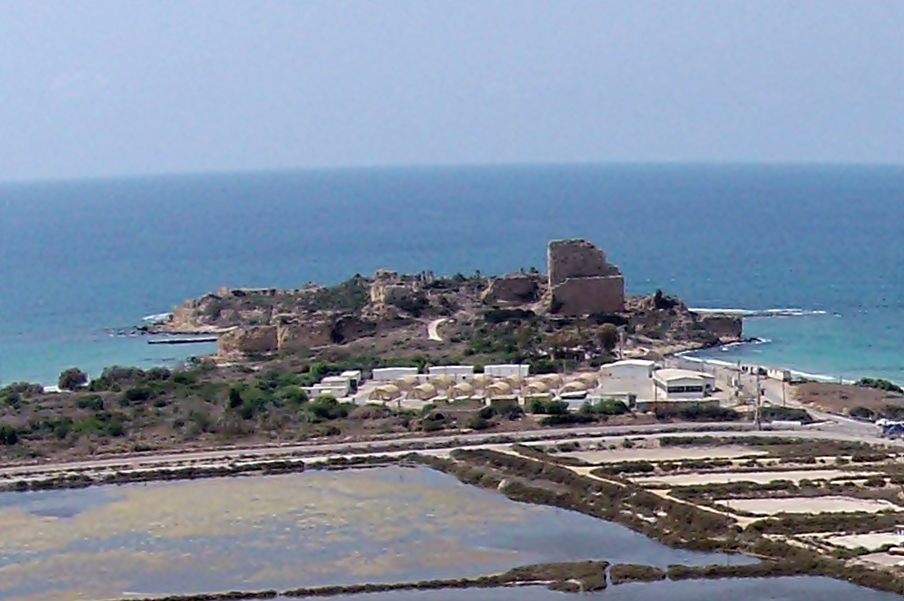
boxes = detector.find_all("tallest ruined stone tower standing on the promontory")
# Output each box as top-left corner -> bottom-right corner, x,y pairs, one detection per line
547,240 -> 625,315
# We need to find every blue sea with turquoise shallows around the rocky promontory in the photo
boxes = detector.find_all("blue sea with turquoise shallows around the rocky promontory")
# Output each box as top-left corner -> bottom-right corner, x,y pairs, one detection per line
0,165 -> 904,383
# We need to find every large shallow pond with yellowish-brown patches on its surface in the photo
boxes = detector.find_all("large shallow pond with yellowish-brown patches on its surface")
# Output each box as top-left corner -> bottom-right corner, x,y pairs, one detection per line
0,467 -> 753,601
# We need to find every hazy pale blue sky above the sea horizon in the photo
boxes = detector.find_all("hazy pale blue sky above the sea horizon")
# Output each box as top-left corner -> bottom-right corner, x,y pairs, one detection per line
0,0 -> 904,180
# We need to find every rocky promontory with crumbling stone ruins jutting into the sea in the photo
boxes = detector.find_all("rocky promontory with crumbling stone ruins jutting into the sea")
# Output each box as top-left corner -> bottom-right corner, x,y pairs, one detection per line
154,240 -> 742,359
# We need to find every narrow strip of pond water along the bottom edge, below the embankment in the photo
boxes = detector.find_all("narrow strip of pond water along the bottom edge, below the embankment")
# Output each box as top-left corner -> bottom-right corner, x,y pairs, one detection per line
292,576 -> 902,601
